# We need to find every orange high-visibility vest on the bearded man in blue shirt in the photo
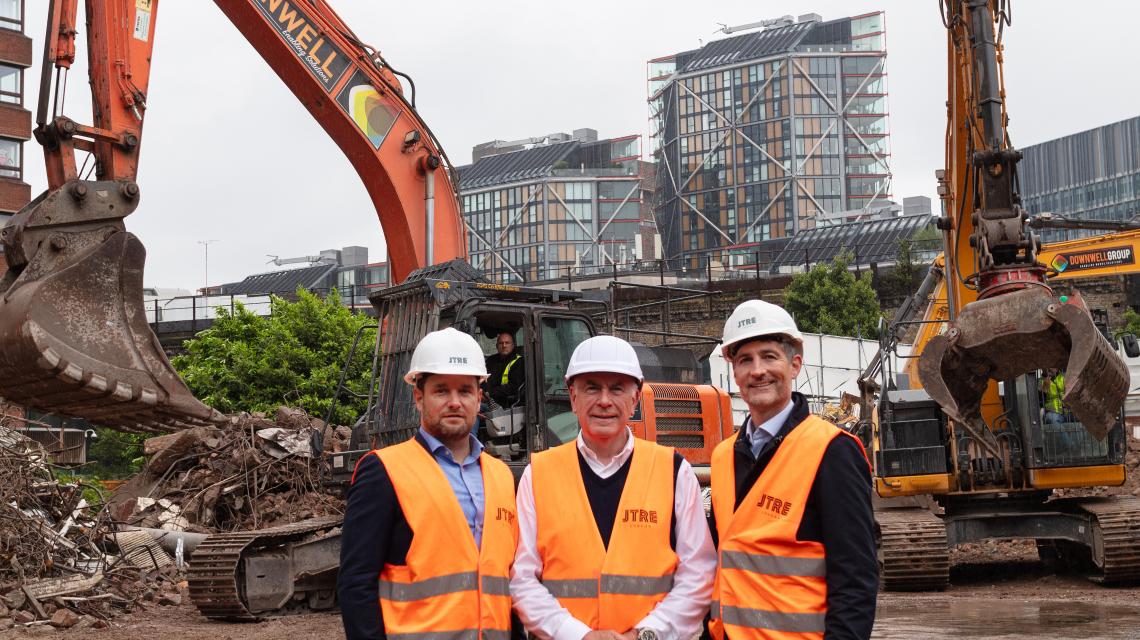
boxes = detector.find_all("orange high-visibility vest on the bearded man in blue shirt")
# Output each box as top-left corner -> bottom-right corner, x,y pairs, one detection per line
373,439 -> 519,640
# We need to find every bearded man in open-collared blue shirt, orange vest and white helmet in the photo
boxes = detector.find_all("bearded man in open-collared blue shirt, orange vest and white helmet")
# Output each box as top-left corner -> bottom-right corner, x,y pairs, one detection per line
337,329 -> 519,640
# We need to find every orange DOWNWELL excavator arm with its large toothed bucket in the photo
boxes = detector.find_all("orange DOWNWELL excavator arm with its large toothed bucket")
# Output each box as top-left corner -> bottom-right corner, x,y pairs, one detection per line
0,0 -> 466,431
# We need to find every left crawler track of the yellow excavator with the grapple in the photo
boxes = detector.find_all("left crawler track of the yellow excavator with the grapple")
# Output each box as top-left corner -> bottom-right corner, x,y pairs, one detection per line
874,508 -> 950,591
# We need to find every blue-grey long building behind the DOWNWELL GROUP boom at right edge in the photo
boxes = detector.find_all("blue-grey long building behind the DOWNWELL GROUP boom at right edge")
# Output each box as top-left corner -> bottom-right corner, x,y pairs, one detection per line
1018,116 -> 1140,242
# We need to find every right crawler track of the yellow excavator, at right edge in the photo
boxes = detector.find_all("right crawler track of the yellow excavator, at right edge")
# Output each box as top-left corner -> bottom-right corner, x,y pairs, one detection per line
1078,497 -> 1140,584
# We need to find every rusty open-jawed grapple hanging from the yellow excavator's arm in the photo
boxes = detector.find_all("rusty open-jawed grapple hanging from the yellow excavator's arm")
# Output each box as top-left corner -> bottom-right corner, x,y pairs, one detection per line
919,286 -> 1129,439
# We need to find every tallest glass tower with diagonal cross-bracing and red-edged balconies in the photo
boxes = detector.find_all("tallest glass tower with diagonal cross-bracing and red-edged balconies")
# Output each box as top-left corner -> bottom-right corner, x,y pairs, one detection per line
649,13 -> 890,265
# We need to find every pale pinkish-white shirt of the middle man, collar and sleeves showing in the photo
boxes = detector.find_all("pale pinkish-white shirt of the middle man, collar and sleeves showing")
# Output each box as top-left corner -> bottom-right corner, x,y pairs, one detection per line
511,428 -> 716,640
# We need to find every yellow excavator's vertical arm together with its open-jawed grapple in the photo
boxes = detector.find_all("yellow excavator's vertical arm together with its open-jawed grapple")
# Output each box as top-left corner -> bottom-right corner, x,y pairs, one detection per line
918,0 -> 1129,441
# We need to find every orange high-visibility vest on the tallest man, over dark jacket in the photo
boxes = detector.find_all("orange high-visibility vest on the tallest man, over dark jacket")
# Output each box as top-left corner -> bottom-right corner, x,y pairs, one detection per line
709,415 -> 866,640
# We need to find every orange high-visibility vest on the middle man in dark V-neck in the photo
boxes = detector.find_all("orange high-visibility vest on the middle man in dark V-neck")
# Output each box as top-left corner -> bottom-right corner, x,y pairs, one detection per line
531,436 -> 677,633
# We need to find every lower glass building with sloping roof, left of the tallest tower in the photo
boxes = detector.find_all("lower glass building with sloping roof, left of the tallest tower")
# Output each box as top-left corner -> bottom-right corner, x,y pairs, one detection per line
458,129 -> 653,284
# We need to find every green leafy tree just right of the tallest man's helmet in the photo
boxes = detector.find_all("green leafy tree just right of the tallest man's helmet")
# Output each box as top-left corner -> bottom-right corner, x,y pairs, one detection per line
784,254 -> 881,338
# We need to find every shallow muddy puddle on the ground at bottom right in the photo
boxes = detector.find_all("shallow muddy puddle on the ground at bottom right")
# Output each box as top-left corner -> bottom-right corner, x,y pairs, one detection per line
871,598 -> 1140,640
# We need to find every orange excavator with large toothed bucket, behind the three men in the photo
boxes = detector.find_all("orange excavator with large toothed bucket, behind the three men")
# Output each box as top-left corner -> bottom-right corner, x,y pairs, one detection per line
0,0 -> 733,619
